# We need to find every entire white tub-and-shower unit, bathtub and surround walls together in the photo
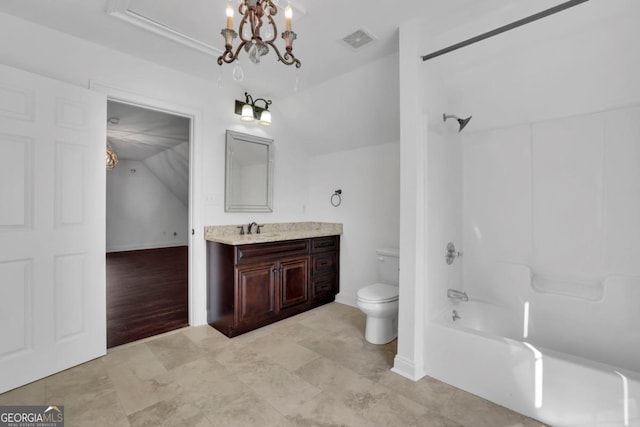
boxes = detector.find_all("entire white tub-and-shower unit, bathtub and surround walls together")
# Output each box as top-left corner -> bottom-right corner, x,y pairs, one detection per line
425,107 -> 640,426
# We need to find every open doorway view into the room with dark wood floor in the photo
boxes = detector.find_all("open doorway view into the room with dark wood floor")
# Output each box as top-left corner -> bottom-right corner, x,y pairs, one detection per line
106,100 -> 191,348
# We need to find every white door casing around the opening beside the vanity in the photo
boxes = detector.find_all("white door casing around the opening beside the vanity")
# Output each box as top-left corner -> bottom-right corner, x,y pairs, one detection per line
89,81 -> 206,326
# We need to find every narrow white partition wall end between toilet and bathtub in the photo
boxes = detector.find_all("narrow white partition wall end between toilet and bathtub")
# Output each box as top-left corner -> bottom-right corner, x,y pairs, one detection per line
392,20 -> 429,381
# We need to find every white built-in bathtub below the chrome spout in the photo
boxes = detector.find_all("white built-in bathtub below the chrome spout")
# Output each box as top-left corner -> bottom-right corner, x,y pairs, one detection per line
425,290 -> 640,427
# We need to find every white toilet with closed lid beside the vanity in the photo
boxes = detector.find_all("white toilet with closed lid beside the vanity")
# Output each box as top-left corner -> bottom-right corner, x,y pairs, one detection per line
356,248 -> 400,344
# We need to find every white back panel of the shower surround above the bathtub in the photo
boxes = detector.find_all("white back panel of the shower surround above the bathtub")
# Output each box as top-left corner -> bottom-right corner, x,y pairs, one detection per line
462,107 -> 640,301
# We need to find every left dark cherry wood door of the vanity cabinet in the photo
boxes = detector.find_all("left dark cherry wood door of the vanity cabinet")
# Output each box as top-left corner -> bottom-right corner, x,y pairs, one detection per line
236,263 -> 278,326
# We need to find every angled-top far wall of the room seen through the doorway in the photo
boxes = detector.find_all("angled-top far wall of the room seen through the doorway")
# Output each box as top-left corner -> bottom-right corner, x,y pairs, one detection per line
106,160 -> 189,252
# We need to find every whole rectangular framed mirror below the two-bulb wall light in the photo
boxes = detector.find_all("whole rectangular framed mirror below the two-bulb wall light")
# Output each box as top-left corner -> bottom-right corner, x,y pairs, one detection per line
224,130 -> 273,212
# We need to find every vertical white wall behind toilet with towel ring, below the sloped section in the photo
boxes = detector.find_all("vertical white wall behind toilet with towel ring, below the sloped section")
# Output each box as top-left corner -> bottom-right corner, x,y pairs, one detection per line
308,142 -> 400,306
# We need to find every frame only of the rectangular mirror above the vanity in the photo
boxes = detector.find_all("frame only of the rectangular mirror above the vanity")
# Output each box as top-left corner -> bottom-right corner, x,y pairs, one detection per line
224,130 -> 273,212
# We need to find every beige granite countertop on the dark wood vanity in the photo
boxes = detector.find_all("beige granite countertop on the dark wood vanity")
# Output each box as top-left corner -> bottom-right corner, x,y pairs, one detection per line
204,222 -> 342,245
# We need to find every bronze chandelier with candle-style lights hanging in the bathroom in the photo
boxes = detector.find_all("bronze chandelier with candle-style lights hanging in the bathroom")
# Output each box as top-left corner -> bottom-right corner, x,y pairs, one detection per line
218,0 -> 301,68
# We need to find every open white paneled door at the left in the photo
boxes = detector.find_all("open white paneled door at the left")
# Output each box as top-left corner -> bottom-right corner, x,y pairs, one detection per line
0,65 -> 106,394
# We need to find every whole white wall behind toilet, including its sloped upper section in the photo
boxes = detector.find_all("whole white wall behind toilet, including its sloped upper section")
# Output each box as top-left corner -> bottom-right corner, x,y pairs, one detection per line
276,49 -> 400,305
